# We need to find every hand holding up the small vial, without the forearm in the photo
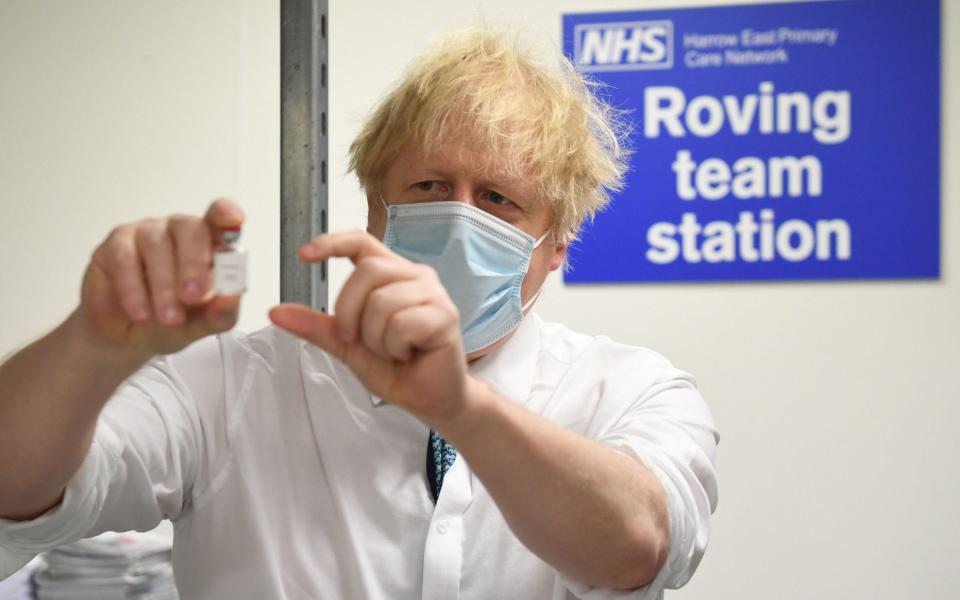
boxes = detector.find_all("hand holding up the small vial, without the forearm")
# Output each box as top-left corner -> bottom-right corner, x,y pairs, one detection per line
75,199 -> 244,357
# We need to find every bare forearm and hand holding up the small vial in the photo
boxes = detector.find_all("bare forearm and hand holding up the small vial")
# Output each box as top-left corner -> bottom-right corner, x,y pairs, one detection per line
0,200 -> 243,519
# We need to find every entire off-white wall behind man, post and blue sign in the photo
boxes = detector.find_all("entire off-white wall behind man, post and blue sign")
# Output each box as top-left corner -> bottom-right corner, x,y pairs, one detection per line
0,0 -> 960,600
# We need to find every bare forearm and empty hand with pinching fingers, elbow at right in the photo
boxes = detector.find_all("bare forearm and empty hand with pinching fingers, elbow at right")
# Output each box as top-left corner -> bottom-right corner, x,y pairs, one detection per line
270,231 -> 669,589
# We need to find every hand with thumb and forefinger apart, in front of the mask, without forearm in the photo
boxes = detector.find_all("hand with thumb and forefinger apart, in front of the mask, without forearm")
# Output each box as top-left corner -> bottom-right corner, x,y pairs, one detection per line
270,231 -> 467,424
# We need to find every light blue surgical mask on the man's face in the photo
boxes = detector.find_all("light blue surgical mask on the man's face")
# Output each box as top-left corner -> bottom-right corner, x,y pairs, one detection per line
380,196 -> 547,354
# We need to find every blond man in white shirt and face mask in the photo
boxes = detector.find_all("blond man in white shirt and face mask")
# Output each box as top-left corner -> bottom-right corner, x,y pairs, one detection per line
0,30 -> 717,599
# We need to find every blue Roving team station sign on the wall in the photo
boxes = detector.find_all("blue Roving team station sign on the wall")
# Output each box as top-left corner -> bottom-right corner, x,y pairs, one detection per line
563,0 -> 941,283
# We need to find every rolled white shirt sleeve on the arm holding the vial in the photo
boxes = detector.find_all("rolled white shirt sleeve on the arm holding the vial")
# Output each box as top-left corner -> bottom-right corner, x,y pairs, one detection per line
0,341 -> 222,579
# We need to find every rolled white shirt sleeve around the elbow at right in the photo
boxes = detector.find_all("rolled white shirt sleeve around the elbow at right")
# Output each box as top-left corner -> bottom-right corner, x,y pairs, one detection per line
561,359 -> 719,600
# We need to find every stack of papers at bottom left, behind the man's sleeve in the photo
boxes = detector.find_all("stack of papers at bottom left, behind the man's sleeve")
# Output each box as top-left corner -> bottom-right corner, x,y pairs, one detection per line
33,532 -> 177,600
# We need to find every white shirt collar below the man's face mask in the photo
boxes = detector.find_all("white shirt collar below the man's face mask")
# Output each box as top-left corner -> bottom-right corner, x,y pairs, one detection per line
370,311 -> 540,406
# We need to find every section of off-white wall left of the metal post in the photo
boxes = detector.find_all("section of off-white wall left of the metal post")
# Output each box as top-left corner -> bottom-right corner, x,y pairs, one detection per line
0,0 -> 280,346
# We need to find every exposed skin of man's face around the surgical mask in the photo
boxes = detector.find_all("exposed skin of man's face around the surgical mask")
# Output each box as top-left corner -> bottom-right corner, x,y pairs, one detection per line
367,138 -> 566,360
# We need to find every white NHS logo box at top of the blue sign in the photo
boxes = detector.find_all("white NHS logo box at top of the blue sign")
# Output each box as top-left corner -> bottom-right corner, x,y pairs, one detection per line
573,21 -> 673,71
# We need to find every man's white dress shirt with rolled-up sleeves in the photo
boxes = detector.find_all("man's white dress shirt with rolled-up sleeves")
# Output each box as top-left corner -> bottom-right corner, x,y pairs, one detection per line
0,315 -> 718,600
